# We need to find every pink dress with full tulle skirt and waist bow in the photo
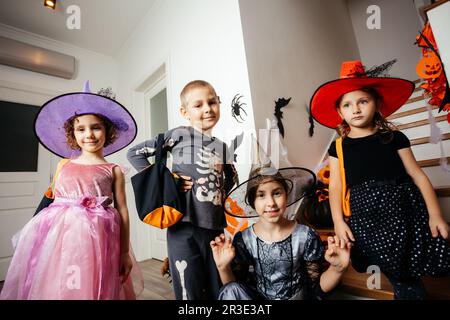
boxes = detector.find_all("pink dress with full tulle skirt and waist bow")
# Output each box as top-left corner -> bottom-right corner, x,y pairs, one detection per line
0,161 -> 143,300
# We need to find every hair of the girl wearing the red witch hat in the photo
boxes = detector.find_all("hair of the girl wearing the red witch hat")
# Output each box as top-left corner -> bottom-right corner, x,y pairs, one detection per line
336,87 -> 397,140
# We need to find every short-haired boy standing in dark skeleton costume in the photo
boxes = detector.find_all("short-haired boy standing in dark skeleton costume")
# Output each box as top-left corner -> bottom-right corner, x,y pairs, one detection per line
127,80 -> 237,300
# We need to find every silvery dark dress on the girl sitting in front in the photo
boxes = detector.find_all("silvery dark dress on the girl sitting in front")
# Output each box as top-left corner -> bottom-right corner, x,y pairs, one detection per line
232,224 -> 324,300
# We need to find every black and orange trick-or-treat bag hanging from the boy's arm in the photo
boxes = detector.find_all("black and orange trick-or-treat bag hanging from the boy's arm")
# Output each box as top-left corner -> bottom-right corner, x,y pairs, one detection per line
131,133 -> 183,229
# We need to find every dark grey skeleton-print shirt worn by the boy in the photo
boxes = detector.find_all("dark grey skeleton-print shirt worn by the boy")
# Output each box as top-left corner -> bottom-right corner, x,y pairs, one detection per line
127,126 -> 237,230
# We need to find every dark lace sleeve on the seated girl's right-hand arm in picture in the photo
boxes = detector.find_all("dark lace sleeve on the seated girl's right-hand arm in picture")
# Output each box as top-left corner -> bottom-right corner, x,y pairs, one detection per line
304,229 -> 325,300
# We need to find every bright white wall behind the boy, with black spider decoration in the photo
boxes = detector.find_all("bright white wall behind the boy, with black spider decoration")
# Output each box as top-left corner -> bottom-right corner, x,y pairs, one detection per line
117,0 -> 254,260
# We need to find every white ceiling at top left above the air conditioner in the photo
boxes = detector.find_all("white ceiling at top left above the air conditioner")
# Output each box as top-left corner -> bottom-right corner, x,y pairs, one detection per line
0,0 -> 155,56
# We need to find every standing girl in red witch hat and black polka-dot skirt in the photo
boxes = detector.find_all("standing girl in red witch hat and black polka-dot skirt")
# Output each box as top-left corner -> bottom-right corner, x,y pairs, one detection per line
311,61 -> 450,299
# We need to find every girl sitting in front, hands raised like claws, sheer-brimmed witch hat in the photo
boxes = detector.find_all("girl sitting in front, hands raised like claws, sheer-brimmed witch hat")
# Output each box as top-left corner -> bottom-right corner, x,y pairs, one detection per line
210,138 -> 351,300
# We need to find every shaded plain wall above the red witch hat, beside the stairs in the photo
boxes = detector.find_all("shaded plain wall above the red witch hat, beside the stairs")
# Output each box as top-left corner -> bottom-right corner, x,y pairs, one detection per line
347,0 -> 422,80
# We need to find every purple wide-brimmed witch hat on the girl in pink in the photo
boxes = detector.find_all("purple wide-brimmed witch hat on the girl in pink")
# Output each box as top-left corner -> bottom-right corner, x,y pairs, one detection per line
34,81 -> 137,158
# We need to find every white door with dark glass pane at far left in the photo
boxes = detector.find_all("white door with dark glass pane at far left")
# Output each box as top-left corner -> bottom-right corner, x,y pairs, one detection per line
0,81 -> 57,281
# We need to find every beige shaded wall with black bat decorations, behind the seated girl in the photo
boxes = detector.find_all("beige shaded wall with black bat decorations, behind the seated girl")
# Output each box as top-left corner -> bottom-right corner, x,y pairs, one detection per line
239,0 -> 359,169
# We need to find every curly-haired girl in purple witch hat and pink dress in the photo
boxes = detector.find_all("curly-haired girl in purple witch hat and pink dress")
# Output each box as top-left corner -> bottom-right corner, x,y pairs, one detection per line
0,82 -> 143,300
